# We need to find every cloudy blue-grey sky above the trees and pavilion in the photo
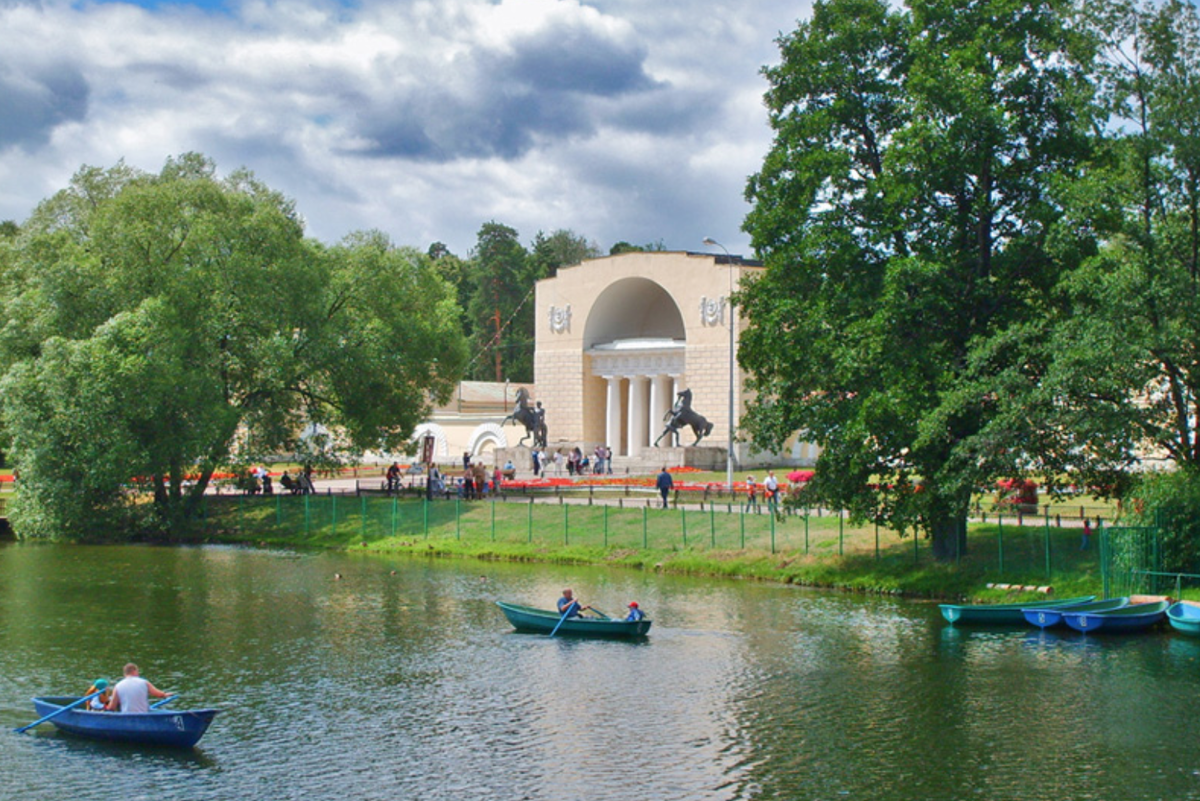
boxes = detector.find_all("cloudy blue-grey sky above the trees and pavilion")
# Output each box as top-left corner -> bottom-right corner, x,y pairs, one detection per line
0,0 -> 810,255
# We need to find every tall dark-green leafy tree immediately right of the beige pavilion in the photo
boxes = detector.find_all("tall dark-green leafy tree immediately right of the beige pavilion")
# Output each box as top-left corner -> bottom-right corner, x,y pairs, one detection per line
740,0 -> 1091,558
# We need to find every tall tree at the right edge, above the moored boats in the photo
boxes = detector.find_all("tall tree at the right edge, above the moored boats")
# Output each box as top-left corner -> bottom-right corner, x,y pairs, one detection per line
1039,0 -> 1200,484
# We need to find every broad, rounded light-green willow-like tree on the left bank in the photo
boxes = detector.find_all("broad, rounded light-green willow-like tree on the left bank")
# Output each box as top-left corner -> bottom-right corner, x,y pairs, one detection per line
0,153 -> 466,536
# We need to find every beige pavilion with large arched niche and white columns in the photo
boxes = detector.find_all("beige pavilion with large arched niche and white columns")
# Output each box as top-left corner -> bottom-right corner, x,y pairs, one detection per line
534,252 -> 761,460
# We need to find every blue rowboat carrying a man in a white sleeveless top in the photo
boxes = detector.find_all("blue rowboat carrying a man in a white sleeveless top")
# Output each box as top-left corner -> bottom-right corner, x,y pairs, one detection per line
34,695 -> 221,748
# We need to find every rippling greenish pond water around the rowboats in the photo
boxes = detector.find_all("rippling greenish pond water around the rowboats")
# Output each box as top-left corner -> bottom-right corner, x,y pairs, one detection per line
0,543 -> 1200,801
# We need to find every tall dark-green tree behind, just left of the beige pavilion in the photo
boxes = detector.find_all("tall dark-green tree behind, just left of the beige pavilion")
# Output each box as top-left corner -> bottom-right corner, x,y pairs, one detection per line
467,222 -> 536,381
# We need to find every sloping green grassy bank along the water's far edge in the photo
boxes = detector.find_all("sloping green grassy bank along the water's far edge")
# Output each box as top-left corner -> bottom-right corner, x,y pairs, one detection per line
171,495 -> 1100,598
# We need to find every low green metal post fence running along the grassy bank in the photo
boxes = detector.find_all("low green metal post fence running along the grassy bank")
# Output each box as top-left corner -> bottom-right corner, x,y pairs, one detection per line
192,493 -> 1098,580
